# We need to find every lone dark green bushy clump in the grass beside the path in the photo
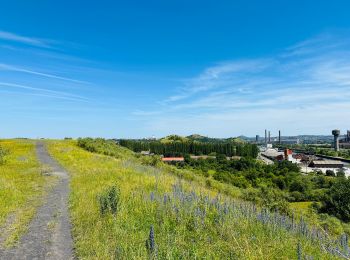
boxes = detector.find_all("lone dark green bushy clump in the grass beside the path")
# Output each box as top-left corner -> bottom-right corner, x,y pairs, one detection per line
98,185 -> 120,216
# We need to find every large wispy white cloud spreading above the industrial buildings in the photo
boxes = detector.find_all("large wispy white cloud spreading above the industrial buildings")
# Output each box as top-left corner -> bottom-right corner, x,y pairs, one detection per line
137,34 -> 350,134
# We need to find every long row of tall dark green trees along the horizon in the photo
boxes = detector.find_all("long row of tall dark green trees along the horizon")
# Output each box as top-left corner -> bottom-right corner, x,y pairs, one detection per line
119,139 -> 259,158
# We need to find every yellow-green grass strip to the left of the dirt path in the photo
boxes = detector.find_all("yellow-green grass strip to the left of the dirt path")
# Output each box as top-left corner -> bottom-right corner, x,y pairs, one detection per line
0,140 -> 53,247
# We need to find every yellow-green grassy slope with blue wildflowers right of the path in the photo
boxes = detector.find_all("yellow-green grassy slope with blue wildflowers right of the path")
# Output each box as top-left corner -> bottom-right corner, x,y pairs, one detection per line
49,141 -> 340,259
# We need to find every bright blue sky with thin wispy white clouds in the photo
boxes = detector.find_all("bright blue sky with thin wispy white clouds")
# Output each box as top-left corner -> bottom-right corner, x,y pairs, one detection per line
0,0 -> 350,138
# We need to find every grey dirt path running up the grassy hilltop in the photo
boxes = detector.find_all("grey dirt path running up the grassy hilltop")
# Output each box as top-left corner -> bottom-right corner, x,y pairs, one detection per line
0,141 -> 73,259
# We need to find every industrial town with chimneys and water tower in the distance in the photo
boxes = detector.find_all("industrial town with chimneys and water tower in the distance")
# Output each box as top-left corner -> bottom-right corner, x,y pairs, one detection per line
258,129 -> 350,177
